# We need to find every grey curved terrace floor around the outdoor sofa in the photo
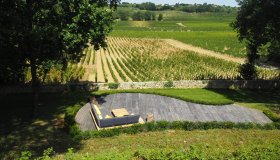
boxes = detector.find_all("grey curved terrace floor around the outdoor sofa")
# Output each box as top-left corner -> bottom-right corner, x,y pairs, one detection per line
76,93 -> 272,131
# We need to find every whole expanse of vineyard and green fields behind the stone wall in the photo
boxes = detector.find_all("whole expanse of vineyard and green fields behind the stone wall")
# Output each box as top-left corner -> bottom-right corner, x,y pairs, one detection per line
30,11 -> 280,84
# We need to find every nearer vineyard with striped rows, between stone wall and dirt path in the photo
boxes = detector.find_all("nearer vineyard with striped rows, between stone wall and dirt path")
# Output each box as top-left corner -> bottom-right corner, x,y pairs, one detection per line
86,37 -> 280,82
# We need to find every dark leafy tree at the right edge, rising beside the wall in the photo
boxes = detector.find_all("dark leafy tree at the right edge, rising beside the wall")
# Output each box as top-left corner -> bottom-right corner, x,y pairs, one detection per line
231,0 -> 280,79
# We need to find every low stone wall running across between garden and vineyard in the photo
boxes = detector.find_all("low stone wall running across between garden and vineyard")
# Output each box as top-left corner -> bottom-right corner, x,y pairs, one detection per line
0,80 -> 280,94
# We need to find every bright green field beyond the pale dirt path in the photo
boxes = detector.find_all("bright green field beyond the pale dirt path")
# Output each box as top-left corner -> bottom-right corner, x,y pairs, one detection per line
110,11 -> 246,57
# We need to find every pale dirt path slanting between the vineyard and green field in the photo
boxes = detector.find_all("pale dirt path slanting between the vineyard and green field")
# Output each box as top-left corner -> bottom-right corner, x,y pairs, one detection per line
164,39 -> 245,64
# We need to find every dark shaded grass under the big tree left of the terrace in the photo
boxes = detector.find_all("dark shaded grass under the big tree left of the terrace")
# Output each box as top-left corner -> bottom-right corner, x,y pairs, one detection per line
0,92 -> 94,159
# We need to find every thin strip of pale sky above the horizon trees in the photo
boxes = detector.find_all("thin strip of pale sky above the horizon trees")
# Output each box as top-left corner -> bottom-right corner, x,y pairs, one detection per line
121,0 -> 237,6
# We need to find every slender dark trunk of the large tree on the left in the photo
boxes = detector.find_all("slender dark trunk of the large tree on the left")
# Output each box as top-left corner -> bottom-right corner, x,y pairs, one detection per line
30,60 -> 40,118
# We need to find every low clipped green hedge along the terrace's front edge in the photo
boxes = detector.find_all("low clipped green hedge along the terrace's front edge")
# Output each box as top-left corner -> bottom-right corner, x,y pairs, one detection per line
77,121 -> 280,139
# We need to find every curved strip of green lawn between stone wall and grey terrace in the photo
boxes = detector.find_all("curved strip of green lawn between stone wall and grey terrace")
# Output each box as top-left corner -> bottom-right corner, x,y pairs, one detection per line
94,88 -> 280,105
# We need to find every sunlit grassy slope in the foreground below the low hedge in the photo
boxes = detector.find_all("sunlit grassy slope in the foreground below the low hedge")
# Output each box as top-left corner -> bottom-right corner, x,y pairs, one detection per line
56,129 -> 280,159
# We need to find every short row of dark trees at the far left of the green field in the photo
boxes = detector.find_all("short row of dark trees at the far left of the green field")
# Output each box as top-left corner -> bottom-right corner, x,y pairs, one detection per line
114,9 -> 163,21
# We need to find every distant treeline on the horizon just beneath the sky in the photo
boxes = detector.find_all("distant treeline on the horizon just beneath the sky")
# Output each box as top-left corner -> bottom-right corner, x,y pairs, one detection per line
120,2 -> 238,13
